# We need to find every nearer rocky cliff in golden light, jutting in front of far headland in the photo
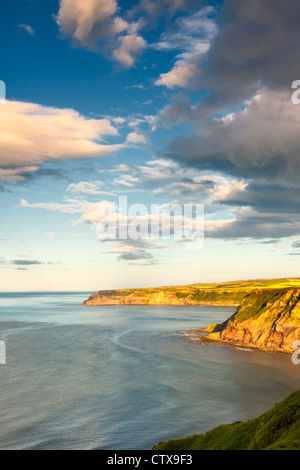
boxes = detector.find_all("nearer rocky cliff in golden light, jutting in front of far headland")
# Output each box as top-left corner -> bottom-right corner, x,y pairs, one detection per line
203,289 -> 300,353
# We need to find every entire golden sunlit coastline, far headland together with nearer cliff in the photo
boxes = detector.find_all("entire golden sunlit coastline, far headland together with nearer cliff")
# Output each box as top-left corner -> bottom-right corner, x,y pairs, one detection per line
84,278 -> 300,353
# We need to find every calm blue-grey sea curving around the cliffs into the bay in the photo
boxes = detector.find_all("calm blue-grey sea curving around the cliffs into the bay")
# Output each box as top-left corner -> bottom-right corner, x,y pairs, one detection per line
0,293 -> 300,450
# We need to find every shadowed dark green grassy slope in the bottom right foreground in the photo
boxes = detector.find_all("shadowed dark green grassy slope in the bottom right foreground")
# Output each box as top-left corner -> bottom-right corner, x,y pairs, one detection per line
154,390 -> 300,450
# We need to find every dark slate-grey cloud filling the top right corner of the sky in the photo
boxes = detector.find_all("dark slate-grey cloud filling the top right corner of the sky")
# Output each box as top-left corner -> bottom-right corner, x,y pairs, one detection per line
203,0 -> 300,105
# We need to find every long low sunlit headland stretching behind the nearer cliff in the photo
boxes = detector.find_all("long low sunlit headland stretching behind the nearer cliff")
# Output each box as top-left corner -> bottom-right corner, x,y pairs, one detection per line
84,278 -> 300,306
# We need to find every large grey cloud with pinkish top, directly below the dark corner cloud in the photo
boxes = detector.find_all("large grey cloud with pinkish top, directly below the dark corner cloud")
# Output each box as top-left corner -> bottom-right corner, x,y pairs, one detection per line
167,89 -> 300,181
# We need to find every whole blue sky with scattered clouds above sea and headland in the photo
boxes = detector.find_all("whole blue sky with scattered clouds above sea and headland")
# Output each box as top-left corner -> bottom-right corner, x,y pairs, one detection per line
0,0 -> 300,292
